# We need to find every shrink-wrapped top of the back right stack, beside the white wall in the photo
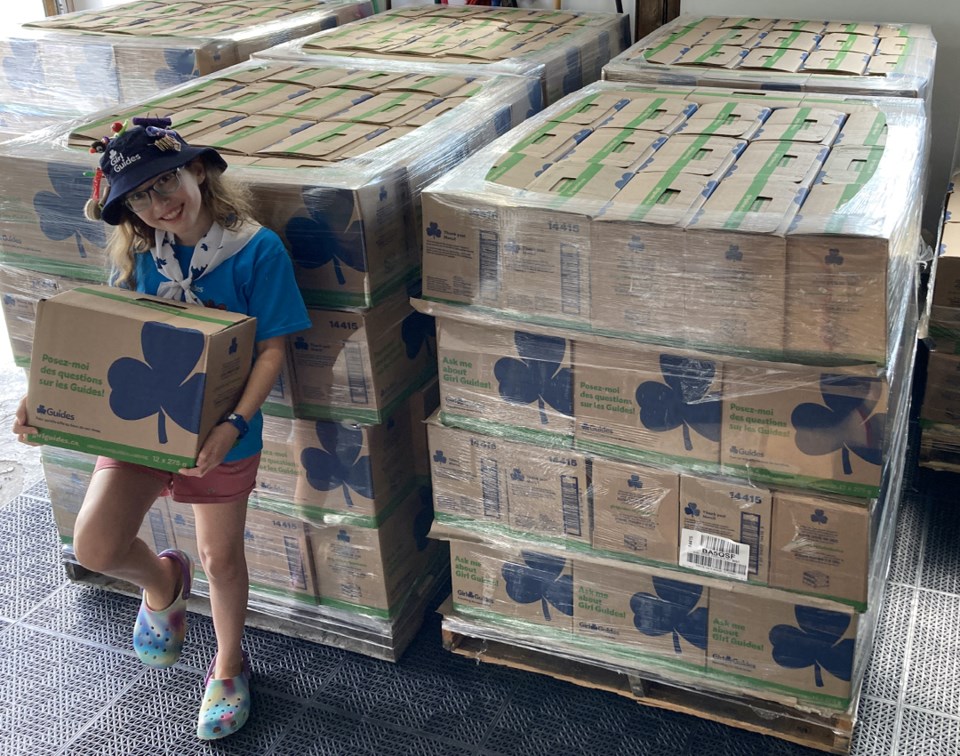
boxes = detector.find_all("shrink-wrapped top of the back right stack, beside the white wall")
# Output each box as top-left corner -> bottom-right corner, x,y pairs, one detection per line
603,14 -> 937,107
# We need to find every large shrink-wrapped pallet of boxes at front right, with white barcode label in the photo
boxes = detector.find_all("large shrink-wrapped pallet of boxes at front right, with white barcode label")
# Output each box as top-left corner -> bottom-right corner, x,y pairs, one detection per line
417,47 -> 928,752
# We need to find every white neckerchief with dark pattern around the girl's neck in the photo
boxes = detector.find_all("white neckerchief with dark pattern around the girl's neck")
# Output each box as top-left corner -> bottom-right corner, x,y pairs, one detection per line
150,222 -> 260,305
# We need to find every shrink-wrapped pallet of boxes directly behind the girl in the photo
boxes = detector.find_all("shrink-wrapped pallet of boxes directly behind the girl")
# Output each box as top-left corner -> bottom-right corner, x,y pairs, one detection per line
0,47 -> 556,659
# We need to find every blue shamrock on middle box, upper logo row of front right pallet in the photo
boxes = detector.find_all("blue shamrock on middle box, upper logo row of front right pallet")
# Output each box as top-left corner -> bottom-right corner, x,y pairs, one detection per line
636,354 -> 721,451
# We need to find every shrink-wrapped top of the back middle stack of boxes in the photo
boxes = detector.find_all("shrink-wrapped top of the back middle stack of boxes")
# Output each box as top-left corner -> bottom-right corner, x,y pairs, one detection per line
258,5 -> 630,103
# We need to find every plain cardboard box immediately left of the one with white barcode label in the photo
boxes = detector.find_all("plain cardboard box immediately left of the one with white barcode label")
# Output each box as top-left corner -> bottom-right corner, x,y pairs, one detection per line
590,457 -> 680,564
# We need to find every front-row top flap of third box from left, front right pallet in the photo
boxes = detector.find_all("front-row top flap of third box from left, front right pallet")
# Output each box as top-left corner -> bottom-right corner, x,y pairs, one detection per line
598,171 -> 716,226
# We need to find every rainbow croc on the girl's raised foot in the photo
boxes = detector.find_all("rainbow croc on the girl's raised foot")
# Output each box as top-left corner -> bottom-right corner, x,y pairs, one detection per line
133,549 -> 193,669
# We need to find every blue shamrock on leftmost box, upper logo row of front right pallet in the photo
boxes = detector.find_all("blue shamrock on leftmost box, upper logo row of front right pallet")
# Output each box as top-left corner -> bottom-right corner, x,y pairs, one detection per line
493,331 -> 573,425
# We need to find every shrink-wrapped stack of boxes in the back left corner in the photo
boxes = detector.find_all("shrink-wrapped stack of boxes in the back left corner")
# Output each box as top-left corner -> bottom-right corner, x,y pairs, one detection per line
0,0 -> 373,116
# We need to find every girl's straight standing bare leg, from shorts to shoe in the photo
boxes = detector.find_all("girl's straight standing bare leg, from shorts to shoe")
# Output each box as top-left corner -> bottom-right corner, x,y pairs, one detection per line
193,497 -> 250,679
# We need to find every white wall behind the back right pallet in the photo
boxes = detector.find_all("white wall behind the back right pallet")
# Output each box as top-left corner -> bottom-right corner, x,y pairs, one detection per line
681,0 -> 960,229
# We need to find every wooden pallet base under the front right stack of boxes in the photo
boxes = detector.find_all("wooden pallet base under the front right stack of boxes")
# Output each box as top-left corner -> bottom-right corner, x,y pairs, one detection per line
441,609 -> 854,754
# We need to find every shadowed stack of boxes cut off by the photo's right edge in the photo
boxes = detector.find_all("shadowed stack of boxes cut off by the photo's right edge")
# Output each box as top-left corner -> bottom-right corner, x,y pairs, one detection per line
920,174 -> 960,472
